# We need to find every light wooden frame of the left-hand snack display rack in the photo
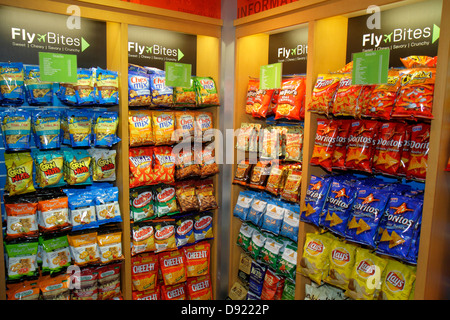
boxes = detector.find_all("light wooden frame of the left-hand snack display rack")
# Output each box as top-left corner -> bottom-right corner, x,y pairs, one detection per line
0,0 -> 222,300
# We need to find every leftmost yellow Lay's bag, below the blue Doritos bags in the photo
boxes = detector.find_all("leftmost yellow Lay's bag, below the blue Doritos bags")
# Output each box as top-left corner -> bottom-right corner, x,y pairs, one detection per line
297,233 -> 333,285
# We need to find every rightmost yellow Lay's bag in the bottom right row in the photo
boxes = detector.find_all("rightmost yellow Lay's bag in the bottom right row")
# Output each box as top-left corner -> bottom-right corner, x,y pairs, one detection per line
378,259 -> 416,300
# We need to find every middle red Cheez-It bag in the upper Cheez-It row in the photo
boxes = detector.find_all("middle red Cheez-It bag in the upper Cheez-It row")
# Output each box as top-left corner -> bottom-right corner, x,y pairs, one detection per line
158,250 -> 187,286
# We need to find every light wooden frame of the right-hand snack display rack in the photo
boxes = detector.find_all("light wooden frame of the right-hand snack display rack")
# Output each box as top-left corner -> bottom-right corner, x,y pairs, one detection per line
229,0 -> 450,300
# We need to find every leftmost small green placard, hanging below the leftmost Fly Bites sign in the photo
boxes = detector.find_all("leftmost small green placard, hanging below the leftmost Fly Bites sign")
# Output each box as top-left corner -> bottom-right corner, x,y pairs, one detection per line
39,52 -> 77,83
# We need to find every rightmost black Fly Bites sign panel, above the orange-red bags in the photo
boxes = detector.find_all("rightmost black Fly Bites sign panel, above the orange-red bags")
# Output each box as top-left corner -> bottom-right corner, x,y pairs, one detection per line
347,0 -> 442,67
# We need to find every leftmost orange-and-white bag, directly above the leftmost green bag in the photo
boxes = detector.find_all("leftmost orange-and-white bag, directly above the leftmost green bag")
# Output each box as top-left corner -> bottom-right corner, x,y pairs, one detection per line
4,196 -> 39,241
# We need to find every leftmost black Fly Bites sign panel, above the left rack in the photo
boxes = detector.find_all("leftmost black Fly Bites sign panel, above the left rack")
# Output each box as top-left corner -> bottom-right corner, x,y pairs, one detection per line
0,6 -> 106,68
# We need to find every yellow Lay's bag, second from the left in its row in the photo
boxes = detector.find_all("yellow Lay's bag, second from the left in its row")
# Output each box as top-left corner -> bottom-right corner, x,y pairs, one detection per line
323,240 -> 357,290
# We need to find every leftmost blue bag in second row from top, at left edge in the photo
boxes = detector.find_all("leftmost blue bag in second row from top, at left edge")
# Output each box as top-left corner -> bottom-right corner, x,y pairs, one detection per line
0,109 -> 31,151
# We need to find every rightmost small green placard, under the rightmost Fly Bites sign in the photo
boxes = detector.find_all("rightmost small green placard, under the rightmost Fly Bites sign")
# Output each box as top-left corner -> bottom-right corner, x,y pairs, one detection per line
352,49 -> 390,85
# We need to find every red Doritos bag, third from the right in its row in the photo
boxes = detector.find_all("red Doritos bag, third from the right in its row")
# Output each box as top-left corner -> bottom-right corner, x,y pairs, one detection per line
345,120 -> 380,173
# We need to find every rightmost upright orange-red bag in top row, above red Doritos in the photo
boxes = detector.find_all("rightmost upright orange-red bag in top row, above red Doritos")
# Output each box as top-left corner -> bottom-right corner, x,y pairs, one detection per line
392,68 -> 436,119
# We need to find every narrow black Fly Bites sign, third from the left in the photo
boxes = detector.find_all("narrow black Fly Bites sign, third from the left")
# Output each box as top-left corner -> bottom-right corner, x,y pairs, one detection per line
269,28 -> 308,75
